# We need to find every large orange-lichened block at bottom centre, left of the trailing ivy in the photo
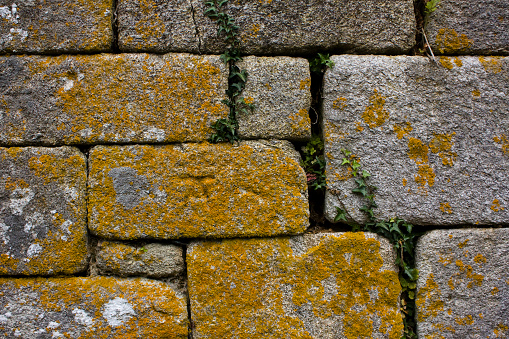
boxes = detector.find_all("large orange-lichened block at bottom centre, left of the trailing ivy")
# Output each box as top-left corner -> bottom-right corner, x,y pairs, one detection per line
186,233 -> 403,339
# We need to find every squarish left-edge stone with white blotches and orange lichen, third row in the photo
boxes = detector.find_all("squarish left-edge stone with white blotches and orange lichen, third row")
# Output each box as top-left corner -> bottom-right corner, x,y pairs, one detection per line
0,147 -> 87,275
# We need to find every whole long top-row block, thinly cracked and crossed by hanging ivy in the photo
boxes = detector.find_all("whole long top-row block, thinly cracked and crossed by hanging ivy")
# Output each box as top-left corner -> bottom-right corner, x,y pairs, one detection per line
119,0 -> 416,55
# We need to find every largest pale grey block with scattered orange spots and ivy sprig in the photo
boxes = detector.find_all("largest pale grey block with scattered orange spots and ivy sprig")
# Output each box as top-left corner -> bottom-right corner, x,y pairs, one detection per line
323,56 -> 509,225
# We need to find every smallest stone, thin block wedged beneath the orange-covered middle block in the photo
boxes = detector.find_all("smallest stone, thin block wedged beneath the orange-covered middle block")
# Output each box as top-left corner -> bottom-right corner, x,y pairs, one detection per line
96,241 -> 185,278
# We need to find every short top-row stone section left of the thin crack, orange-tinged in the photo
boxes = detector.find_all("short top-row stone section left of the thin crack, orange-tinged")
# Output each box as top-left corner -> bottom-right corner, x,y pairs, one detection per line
117,0 -> 199,53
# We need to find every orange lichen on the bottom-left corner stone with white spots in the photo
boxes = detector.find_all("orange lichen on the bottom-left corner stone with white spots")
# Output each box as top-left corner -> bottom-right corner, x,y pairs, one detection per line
0,277 -> 188,339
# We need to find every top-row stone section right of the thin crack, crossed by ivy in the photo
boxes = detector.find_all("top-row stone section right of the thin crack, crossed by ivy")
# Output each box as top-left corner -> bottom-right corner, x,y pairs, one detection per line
191,0 -> 416,55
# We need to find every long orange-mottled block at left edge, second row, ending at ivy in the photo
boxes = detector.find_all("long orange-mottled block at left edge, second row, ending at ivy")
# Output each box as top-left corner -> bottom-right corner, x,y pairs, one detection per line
0,54 -> 228,145
